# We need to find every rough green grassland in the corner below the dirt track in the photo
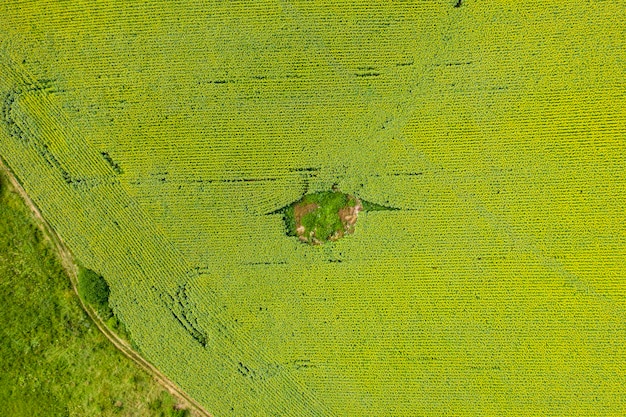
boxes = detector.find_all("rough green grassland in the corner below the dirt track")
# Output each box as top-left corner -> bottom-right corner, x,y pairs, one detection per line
0,171 -> 188,417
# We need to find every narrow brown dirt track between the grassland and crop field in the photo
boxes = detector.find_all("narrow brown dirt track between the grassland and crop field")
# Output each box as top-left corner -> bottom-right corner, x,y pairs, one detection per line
0,158 -> 212,417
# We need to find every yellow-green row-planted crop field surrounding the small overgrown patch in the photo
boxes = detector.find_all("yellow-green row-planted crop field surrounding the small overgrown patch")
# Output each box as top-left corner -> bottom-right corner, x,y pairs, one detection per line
0,0 -> 626,417
